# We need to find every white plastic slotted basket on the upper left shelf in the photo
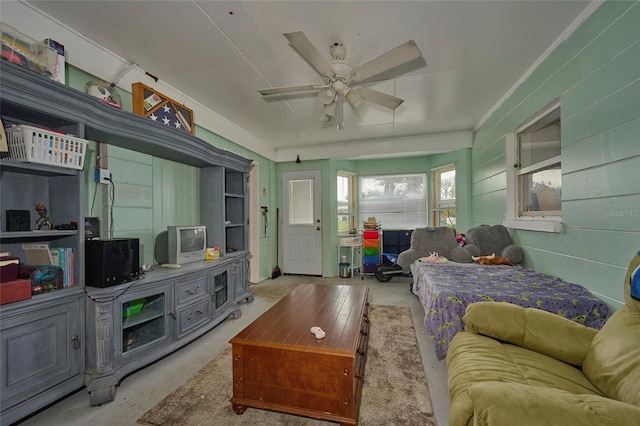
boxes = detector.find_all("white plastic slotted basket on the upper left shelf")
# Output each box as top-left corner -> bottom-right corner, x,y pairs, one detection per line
6,125 -> 87,170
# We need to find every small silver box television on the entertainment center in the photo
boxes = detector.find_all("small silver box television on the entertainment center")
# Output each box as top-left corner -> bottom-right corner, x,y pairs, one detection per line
155,225 -> 207,265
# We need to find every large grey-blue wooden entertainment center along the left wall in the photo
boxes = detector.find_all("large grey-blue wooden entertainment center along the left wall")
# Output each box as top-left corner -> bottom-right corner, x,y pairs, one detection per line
0,61 -> 253,425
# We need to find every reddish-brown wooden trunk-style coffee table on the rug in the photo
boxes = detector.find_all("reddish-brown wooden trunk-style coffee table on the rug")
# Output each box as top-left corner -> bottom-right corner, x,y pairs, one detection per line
230,284 -> 369,425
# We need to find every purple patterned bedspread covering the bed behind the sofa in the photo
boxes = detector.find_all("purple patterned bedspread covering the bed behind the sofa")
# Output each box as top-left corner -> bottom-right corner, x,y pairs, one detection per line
413,263 -> 611,359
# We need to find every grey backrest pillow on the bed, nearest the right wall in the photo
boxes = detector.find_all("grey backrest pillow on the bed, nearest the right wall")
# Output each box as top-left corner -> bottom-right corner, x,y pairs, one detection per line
454,225 -> 524,263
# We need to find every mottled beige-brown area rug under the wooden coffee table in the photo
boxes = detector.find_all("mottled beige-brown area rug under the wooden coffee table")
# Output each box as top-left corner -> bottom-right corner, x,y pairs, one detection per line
138,305 -> 436,426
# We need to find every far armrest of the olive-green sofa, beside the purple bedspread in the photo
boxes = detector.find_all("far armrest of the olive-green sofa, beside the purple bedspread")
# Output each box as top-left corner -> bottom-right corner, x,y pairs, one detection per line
462,302 -> 598,366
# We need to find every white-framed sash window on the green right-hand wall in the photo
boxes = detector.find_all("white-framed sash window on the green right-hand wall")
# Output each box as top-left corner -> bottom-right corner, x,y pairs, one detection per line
505,103 -> 562,232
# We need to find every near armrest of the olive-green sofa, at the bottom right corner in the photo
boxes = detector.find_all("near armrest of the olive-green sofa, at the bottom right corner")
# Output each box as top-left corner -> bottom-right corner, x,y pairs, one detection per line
468,382 -> 640,426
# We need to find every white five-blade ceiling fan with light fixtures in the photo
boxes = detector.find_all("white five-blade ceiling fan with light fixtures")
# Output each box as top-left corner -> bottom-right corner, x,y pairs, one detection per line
258,31 -> 422,129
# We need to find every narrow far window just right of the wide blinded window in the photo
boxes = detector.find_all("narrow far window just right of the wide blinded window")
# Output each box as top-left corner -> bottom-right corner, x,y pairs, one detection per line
432,164 -> 456,229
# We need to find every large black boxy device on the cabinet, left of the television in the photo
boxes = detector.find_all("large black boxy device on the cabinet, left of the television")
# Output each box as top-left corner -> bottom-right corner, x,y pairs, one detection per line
85,238 -> 140,288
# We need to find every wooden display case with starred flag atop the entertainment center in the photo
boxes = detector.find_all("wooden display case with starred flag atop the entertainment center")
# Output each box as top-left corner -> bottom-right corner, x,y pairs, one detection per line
132,83 -> 194,134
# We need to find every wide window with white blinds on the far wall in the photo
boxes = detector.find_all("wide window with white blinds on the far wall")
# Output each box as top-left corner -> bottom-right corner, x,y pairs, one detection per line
358,174 -> 427,228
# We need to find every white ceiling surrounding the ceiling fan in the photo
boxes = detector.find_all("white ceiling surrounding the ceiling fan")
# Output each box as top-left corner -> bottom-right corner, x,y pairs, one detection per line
28,0 -> 590,160
